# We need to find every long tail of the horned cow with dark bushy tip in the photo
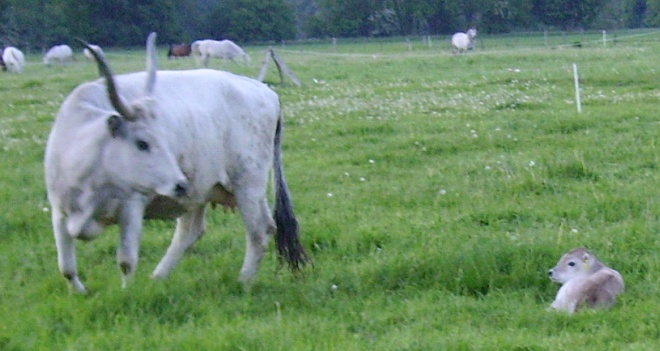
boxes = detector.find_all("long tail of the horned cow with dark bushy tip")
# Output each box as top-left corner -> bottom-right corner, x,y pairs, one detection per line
273,114 -> 309,271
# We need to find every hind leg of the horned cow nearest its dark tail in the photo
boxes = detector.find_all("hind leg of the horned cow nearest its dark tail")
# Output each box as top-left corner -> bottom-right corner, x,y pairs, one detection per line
236,191 -> 276,284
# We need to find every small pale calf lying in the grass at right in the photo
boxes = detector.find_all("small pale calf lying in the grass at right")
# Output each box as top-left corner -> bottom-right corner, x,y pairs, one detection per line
548,248 -> 624,314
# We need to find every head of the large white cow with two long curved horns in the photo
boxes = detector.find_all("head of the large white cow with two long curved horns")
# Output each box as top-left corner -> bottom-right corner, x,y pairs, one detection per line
81,33 -> 188,197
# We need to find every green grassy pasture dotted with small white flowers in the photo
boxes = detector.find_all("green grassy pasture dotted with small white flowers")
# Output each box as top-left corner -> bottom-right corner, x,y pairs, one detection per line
0,31 -> 660,350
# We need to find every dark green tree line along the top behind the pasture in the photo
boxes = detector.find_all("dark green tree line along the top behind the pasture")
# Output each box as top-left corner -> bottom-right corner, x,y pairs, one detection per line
0,0 -> 660,50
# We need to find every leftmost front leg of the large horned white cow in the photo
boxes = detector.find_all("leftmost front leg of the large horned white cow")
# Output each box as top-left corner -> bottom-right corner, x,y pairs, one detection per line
51,207 -> 87,294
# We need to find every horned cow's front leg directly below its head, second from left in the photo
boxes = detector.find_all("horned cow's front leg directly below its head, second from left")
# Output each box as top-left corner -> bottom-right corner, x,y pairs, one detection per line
117,199 -> 145,288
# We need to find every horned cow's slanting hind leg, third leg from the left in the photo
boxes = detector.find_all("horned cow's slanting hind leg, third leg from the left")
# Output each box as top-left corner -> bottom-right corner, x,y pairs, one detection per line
151,205 -> 206,278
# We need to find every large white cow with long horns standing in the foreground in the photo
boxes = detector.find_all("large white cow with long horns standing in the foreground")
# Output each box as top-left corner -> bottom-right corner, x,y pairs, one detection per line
45,33 -> 307,293
